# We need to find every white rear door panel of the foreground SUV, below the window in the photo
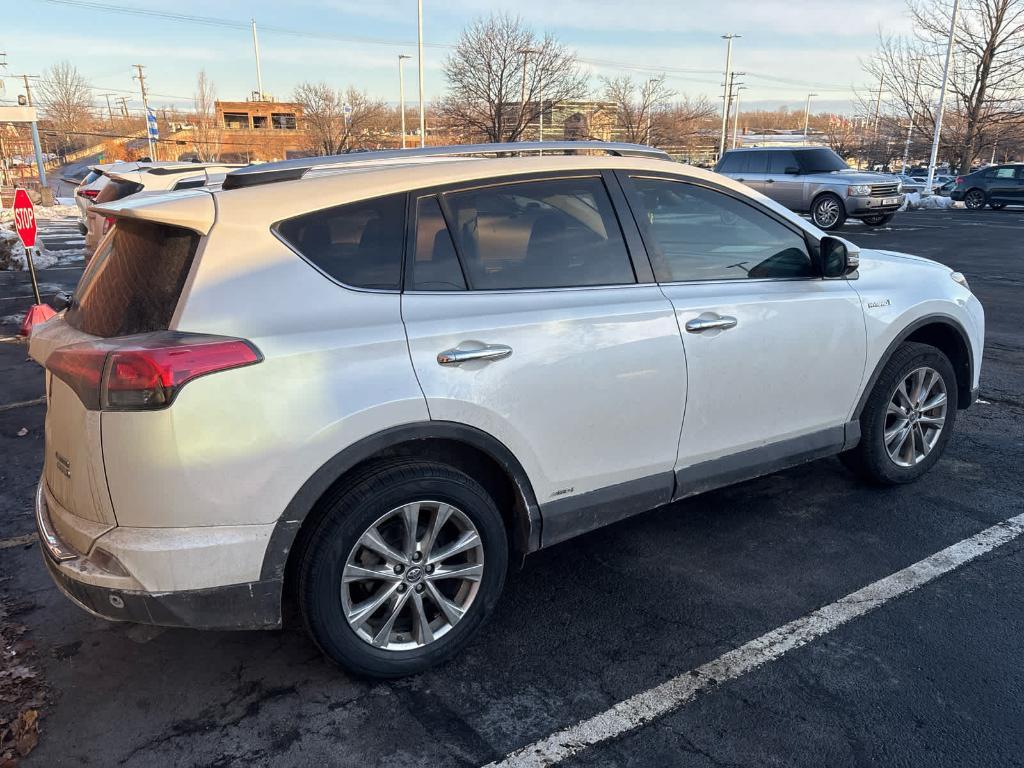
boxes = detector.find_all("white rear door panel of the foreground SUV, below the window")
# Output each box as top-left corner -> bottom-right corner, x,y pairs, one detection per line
402,285 -> 686,509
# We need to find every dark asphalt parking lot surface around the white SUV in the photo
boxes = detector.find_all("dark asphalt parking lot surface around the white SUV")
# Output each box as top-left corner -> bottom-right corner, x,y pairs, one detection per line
0,209 -> 1024,766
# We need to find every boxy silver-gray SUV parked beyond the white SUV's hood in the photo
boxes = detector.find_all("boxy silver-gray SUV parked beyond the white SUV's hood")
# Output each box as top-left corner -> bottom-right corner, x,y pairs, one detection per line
715,146 -> 903,229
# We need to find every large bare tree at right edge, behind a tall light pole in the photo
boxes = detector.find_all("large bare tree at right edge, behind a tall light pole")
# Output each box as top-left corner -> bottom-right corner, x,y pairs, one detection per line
864,0 -> 1024,172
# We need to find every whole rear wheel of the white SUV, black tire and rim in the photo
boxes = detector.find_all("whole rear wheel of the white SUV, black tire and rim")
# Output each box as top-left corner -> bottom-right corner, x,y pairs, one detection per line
297,460 -> 509,678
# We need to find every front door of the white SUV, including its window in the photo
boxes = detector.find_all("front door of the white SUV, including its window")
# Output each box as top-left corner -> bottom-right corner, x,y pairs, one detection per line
621,174 -> 865,472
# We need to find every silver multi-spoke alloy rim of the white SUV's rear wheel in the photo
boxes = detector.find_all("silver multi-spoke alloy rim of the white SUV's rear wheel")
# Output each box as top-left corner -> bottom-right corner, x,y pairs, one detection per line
341,500 -> 483,650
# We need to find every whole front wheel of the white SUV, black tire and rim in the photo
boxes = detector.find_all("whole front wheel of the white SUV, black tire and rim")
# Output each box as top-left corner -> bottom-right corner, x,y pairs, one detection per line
841,342 -> 957,485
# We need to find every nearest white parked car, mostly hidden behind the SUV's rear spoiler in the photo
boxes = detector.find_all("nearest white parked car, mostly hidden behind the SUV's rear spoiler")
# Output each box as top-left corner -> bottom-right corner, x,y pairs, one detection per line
85,163 -> 243,260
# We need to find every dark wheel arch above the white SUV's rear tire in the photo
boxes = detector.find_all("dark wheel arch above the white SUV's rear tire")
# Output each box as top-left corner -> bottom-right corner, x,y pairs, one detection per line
260,421 -> 541,583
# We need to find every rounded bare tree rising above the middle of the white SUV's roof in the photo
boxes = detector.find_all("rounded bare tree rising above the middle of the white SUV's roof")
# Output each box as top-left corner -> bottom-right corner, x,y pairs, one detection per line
440,13 -> 587,141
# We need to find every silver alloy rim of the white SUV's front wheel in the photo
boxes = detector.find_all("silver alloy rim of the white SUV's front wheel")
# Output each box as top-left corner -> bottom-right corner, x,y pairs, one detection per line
883,367 -> 948,467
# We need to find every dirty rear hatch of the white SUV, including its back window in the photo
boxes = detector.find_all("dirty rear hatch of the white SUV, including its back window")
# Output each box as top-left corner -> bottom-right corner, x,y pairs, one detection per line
29,214 -> 209,553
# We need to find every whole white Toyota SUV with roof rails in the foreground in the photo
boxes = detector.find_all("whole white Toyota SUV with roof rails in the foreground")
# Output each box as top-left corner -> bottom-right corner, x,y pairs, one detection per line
31,142 -> 984,677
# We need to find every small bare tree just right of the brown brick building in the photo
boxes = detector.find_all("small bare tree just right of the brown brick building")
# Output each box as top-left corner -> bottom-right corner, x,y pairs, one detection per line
295,82 -> 389,155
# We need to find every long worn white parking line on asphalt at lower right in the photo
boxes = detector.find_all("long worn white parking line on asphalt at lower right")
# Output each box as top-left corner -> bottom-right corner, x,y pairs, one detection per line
485,514 -> 1024,768
